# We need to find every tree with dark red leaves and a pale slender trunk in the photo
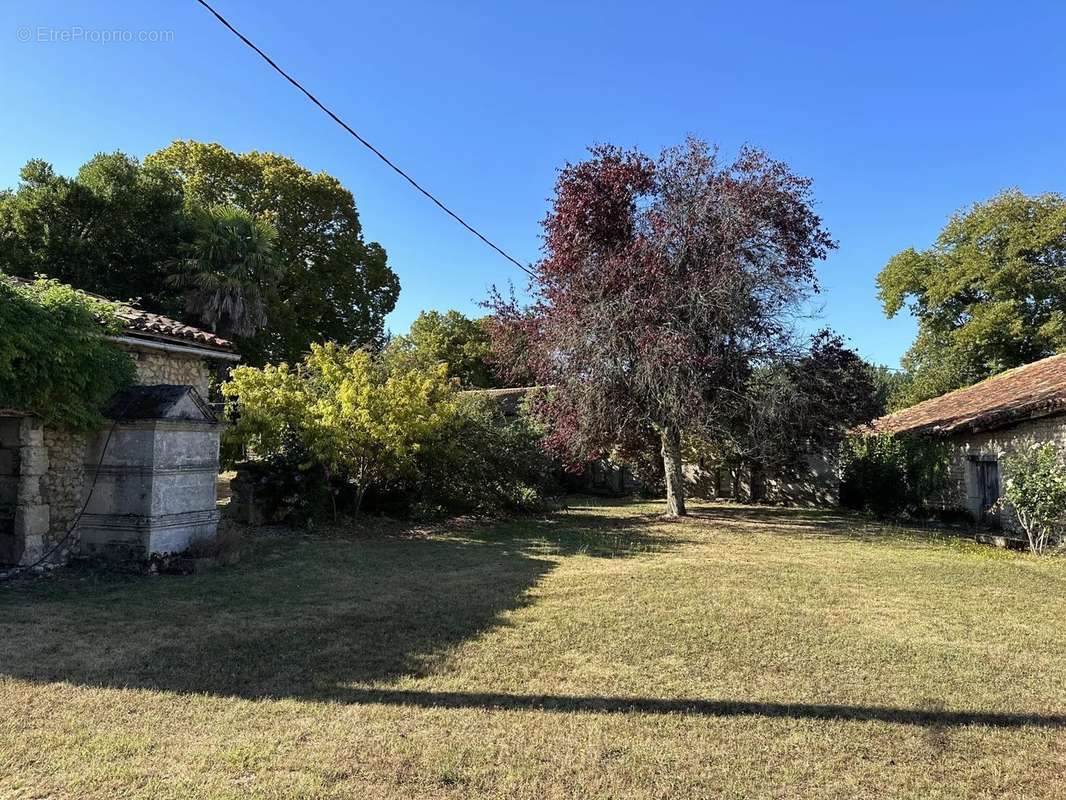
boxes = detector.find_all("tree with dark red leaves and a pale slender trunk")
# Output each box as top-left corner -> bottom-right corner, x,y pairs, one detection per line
491,140 -> 834,514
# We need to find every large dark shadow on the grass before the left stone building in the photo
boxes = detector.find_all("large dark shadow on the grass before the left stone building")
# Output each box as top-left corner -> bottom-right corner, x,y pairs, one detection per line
0,514 -> 677,700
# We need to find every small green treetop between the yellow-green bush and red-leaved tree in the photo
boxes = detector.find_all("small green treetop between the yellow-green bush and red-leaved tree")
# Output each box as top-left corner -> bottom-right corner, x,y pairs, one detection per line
389,310 -> 500,388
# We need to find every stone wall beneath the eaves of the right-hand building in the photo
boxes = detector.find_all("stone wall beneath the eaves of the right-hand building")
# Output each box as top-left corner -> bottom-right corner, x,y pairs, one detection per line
934,414 -> 1066,529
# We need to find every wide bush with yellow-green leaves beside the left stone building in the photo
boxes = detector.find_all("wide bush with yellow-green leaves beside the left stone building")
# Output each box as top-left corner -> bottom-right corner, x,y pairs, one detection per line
223,345 -> 554,524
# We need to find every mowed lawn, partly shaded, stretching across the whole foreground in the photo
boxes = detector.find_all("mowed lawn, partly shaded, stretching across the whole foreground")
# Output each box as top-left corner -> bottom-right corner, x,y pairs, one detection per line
0,501 -> 1066,800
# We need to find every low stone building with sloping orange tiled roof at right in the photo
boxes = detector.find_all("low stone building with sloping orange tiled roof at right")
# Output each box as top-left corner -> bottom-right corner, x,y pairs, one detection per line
871,353 -> 1066,529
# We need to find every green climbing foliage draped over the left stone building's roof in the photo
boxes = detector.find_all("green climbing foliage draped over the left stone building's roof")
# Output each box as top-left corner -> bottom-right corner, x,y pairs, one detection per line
0,274 -> 134,430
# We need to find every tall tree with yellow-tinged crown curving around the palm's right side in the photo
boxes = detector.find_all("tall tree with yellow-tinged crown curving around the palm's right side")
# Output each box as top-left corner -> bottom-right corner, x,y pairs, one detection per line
145,141 -> 400,364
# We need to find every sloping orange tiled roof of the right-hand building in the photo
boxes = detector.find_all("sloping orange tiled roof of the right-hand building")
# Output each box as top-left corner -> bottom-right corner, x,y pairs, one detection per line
869,353 -> 1066,435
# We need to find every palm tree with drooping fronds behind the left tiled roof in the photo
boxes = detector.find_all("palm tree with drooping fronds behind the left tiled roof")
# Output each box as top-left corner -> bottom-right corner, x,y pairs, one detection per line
167,206 -> 279,338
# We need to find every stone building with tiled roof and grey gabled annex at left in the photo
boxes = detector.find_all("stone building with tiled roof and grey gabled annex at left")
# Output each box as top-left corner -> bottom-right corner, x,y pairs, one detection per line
0,278 -> 238,565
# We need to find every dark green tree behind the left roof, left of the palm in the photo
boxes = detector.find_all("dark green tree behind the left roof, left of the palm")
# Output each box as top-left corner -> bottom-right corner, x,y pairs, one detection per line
0,153 -> 188,314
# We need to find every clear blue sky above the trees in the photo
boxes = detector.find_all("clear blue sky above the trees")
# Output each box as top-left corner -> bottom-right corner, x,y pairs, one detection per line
0,0 -> 1066,364
